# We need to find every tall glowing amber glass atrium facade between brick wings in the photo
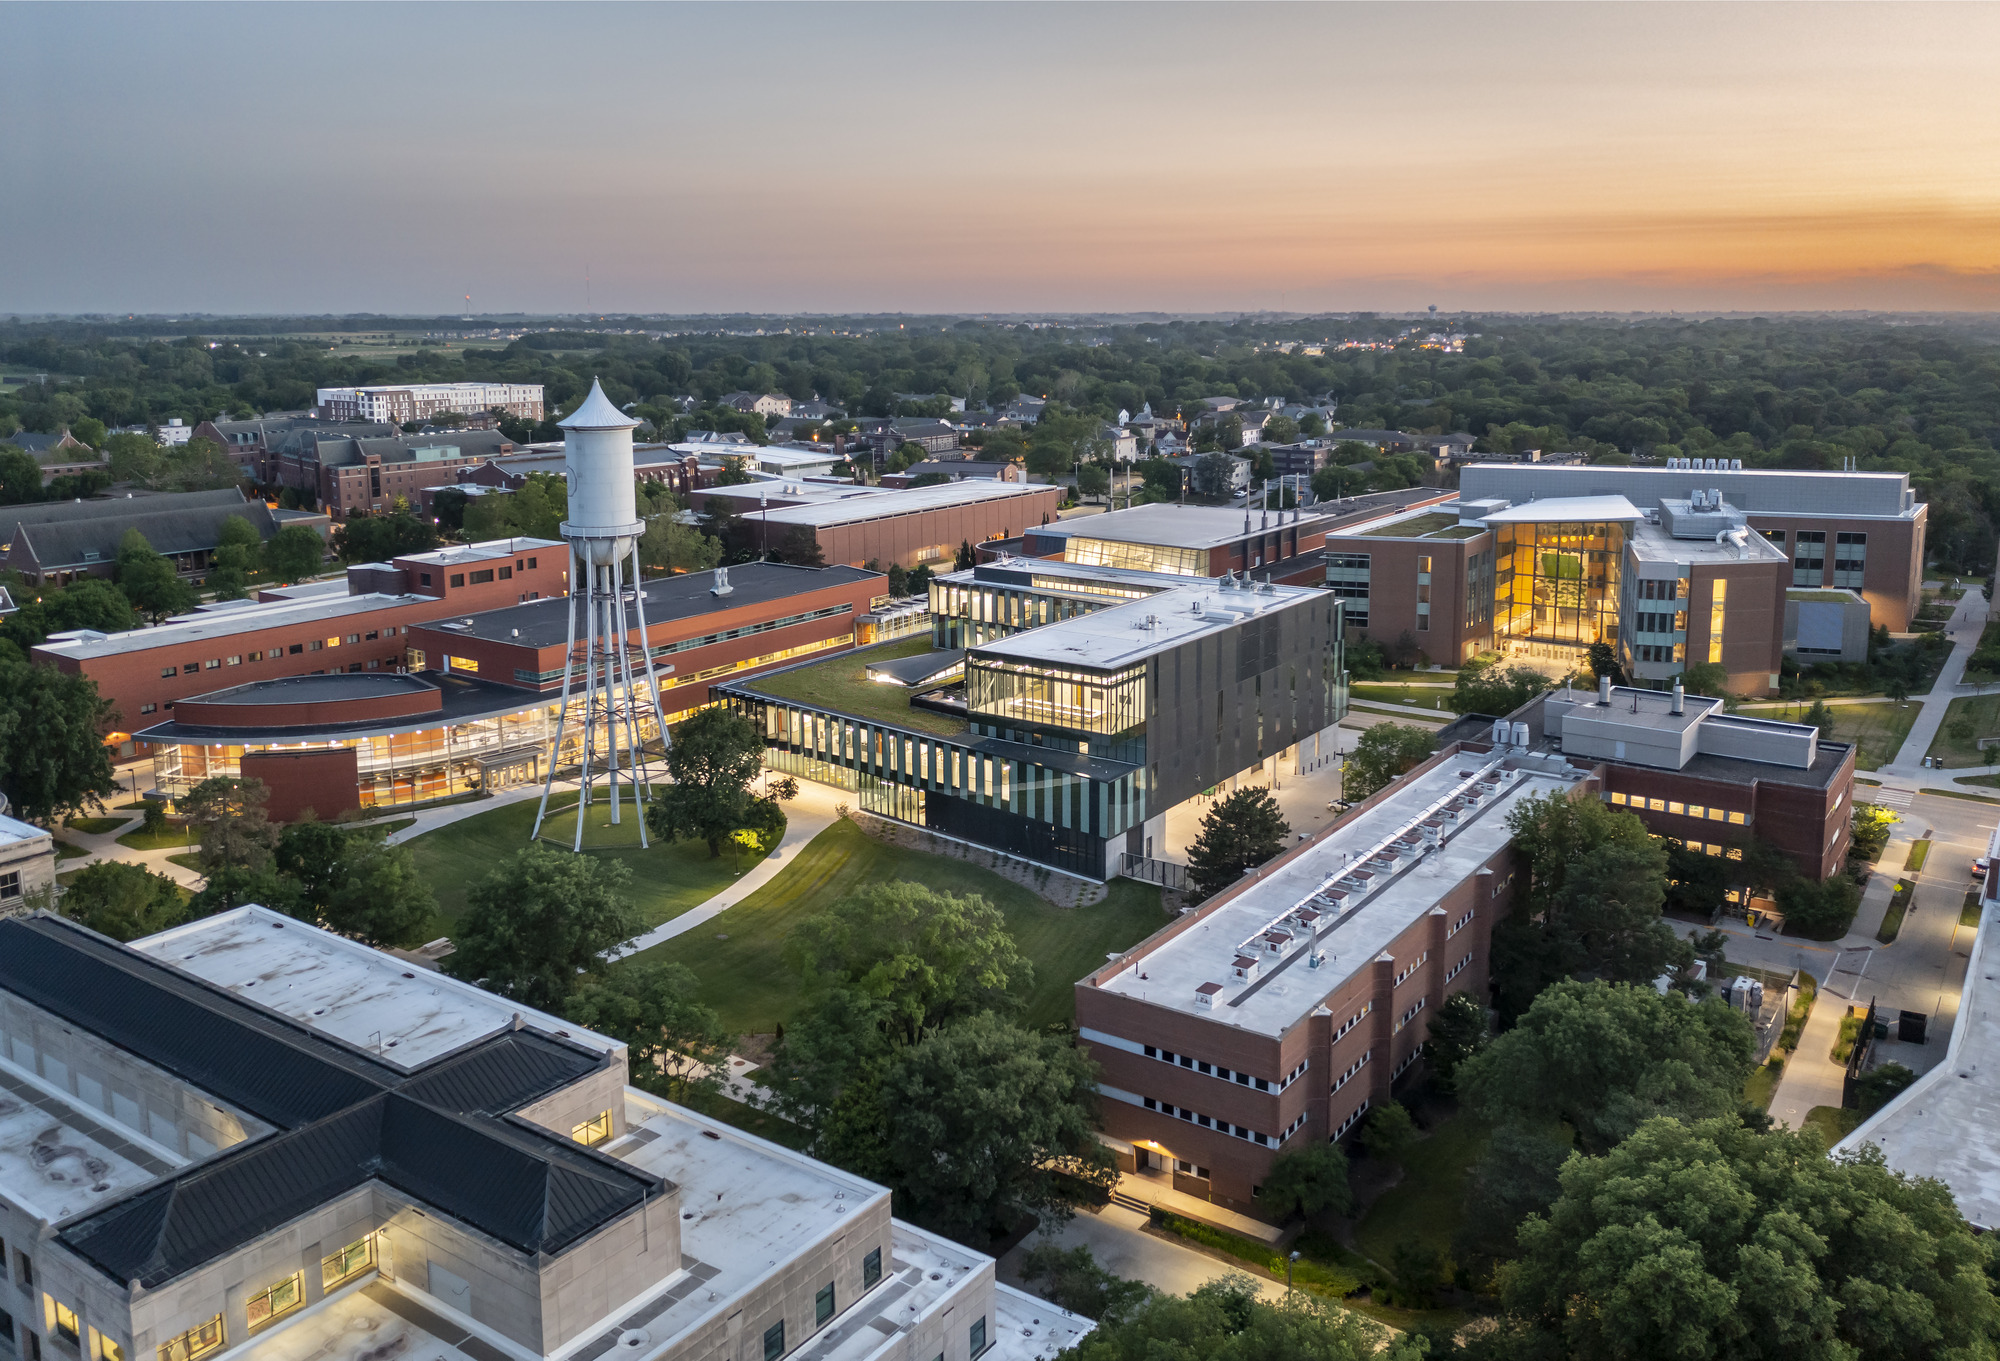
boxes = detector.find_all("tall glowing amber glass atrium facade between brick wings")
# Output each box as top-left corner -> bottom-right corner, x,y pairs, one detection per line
1494,522 -> 1626,664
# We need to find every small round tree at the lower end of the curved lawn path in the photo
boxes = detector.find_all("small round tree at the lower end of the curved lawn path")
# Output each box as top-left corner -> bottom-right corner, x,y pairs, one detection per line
564,961 -> 736,1101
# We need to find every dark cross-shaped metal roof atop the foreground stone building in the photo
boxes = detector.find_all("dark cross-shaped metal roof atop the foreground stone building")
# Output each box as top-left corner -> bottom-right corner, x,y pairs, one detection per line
0,913 -> 666,1287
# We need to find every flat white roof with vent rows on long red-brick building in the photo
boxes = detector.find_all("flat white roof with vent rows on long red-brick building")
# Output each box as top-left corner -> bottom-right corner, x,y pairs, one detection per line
1098,751 -> 1582,1037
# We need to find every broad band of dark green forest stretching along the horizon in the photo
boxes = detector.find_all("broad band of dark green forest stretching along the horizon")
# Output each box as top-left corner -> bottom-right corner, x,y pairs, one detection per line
0,318 -> 2000,568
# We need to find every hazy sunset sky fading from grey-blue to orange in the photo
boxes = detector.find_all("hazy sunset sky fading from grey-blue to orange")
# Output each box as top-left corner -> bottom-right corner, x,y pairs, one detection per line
0,4 -> 2000,312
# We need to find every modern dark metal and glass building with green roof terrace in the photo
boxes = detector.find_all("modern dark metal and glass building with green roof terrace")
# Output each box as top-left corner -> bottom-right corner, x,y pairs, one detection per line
716,558 -> 1346,879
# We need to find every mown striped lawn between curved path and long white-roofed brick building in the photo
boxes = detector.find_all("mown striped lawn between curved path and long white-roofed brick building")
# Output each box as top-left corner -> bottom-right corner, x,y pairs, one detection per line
644,819 -> 1166,1035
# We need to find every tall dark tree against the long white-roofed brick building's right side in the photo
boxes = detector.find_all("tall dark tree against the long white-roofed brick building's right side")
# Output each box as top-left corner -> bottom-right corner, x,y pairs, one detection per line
1494,795 -> 1694,1017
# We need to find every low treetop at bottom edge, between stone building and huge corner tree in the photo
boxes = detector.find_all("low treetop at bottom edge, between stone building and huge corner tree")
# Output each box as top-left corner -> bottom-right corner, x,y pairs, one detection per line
1066,1275 -> 1400,1361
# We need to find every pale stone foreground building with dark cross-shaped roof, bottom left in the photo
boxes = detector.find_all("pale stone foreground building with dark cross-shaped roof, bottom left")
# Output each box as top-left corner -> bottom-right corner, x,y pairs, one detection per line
0,907 -> 1090,1361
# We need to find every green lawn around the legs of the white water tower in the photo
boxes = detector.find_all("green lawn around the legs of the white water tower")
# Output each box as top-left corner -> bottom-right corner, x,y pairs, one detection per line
404,795 -> 756,927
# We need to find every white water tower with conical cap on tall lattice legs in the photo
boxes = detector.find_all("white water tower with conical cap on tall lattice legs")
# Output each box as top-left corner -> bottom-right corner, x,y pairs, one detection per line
532,380 -> 666,851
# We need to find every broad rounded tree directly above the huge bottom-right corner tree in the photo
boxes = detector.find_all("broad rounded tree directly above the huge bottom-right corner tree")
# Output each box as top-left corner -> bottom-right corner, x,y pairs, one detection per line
1458,983 -> 1756,1153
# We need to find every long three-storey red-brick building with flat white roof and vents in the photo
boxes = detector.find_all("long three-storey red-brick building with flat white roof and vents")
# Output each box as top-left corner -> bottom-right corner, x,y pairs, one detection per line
1076,745 -> 1588,1213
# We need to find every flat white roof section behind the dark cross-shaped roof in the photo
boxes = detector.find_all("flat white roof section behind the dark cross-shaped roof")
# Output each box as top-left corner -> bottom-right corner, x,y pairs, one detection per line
132,905 -> 622,1069
